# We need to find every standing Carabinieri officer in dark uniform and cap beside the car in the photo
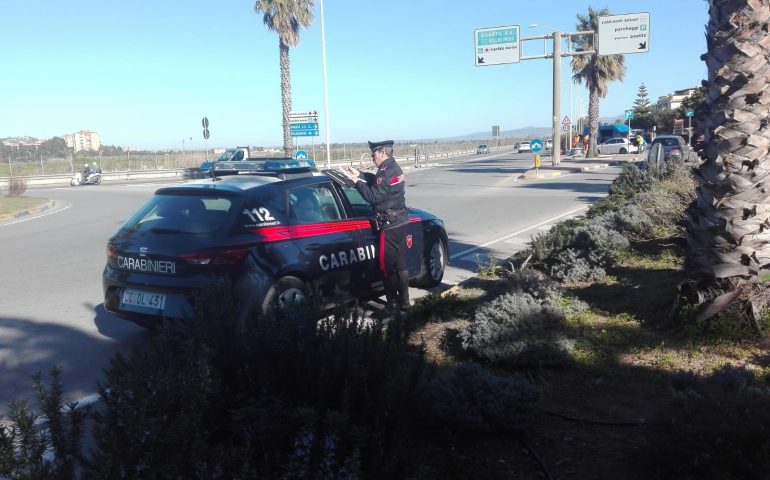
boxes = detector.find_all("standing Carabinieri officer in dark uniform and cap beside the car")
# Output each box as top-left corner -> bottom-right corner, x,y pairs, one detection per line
344,140 -> 409,312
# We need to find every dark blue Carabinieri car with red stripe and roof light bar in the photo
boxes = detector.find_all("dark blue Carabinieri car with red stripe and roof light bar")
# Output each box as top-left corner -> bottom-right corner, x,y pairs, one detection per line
102,159 -> 448,327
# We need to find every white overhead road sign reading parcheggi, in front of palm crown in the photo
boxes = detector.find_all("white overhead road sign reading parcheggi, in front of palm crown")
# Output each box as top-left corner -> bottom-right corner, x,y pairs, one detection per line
597,12 -> 650,55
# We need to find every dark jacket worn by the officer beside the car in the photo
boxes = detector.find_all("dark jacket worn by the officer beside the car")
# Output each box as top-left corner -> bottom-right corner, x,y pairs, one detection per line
356,157 -> 406,216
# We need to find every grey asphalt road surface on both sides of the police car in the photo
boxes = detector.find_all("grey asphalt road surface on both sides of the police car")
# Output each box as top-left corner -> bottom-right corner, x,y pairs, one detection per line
0,153 -> 619,416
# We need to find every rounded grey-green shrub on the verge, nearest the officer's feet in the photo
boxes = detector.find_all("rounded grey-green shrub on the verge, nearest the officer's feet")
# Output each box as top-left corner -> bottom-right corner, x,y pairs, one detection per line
458,291 -> 573,366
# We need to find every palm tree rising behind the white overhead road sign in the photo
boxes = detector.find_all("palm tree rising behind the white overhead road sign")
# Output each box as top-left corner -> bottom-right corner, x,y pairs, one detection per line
570,7 -> 626,157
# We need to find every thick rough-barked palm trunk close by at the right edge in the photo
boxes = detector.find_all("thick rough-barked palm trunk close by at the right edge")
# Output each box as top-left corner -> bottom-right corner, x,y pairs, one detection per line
688,0 -> 770,289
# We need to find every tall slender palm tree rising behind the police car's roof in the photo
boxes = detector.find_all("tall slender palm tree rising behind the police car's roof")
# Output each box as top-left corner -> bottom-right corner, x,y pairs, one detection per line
254,0 -> 313,157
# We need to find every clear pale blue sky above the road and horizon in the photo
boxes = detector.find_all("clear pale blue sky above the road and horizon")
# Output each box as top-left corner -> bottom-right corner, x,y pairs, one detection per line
0,0 -> 708,150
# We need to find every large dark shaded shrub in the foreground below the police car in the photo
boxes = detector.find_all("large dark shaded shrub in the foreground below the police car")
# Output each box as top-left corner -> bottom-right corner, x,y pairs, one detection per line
90,286 -> 425,478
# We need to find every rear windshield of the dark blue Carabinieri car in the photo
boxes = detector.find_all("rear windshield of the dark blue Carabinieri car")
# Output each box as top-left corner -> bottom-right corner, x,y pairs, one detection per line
120,194 -> 237,235
